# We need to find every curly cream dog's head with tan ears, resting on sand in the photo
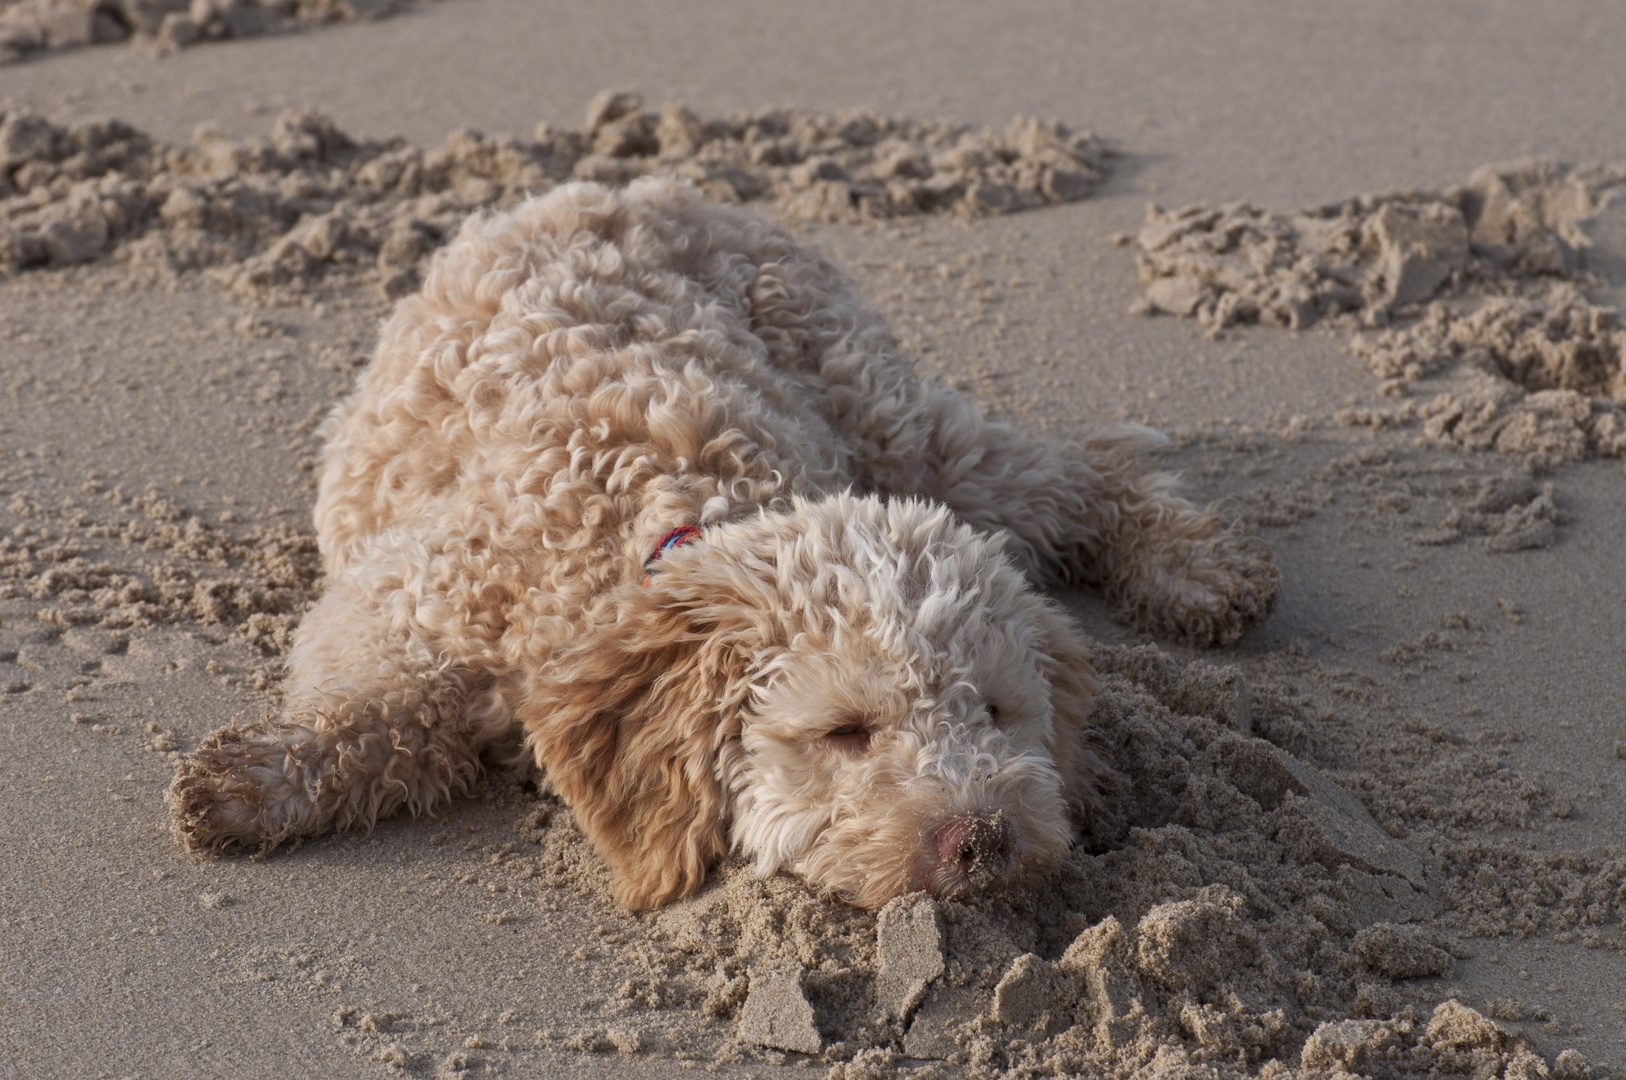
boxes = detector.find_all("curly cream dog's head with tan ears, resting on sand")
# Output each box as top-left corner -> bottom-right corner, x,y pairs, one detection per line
525,496 -> 1101,908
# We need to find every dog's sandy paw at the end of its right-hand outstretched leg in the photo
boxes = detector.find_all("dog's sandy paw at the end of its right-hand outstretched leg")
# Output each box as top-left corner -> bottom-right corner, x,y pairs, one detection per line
1135,532 -> 1281,647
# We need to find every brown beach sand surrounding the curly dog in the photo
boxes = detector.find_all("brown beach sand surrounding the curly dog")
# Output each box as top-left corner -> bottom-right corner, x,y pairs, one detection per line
0,0 -> 1626,1080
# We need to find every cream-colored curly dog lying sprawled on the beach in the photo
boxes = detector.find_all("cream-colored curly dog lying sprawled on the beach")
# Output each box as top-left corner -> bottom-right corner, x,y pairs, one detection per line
169,181 -> 1278,908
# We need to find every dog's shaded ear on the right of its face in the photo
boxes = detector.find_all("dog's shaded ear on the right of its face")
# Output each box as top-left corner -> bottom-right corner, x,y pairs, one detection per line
1039,600 -> 1120,843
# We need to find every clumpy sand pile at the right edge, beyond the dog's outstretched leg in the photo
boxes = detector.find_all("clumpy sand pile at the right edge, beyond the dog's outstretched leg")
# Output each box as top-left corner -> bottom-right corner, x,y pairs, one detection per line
1135,161 -> 1626,460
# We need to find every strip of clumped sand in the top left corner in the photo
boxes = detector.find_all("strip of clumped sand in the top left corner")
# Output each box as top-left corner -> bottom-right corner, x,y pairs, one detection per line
0,0 -> 400,63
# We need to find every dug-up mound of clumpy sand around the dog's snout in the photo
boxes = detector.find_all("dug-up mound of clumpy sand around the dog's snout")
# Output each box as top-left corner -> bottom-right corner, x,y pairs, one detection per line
504,644 -> 1626,1080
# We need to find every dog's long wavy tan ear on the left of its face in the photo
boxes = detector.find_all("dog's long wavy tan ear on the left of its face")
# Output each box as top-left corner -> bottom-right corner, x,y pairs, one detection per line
520,586 -> 767,911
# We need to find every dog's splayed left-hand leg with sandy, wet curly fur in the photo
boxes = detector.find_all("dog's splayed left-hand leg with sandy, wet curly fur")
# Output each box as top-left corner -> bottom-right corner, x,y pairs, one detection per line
169,568 -> 512,851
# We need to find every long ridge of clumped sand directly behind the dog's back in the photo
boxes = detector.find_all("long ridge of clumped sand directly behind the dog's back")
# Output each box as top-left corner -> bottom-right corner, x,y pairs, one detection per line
0,91 -> 1109,299
